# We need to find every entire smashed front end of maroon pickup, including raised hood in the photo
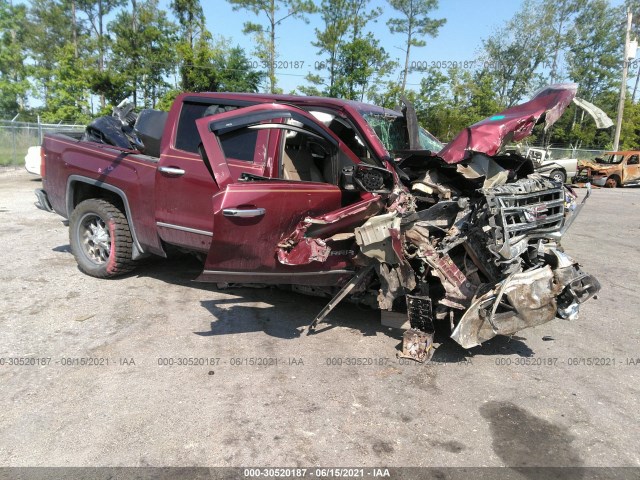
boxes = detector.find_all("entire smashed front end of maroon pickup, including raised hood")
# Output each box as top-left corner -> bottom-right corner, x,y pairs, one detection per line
278,85 -> 600,361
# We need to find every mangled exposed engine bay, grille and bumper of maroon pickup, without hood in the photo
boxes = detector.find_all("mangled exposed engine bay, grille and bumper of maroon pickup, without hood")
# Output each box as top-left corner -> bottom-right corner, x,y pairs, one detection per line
340,149 -> 600,356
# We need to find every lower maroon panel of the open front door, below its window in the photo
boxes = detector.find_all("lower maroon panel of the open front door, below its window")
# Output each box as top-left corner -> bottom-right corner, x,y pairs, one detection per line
200,182 -> 350,285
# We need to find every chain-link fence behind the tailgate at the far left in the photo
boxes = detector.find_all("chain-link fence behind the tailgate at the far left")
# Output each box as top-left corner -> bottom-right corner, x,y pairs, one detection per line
0,120 -> 85,165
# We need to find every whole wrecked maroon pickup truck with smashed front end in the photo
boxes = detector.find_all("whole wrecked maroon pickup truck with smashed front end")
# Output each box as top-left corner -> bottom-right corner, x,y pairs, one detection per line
36,85 -> 600,360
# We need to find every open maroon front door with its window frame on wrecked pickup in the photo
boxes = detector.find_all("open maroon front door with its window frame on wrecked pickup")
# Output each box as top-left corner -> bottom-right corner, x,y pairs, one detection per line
196,104 -> 357,285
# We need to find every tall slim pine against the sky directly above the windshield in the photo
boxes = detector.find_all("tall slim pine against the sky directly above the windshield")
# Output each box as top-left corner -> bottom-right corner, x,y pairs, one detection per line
387,0 -> 446,93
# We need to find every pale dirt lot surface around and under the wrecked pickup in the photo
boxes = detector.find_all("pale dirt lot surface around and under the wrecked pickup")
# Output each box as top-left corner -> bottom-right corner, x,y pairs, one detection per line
0,170 -> 640,467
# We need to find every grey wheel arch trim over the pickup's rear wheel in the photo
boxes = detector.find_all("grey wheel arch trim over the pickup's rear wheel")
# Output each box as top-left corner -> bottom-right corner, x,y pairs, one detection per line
66,175 -> 146,260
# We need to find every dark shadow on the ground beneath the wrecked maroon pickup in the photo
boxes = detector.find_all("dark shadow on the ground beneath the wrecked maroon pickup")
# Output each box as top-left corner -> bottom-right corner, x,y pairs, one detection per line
53,245 -> 534,363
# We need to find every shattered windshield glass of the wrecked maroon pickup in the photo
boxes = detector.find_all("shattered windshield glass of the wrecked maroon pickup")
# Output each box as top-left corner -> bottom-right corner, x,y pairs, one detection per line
361,112 -> 444,152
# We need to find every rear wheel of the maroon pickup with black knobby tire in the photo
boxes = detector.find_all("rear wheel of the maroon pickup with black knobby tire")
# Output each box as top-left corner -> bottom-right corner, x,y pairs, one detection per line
69,198 -> 135,278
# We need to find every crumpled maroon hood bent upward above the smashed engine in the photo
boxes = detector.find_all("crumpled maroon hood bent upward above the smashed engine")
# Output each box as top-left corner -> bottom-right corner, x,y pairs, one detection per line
438,83 -> 578,163
